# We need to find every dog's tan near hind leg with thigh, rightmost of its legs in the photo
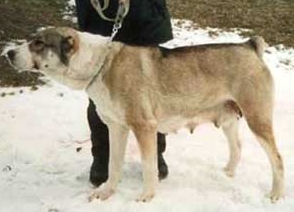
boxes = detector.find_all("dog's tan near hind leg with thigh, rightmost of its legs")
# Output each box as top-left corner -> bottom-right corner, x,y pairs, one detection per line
238,76 -> 284,202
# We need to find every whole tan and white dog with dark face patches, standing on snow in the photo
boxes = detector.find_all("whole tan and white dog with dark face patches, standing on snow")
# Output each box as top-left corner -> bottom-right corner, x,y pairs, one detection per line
7,28 -> 284,202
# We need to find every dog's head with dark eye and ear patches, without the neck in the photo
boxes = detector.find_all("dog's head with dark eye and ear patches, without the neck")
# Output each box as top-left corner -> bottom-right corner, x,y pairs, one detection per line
7,28 -> 79,71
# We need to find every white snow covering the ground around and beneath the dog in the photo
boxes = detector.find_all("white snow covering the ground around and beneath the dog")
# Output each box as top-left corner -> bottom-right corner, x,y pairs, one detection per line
0,13 -> 294,212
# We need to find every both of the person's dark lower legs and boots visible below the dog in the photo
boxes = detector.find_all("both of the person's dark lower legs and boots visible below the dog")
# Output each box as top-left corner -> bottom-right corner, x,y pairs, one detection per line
88,100 -> 168,186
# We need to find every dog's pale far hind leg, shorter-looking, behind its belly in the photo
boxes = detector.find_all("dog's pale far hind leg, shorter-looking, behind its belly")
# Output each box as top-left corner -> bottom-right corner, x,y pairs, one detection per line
222,118 -> 241,177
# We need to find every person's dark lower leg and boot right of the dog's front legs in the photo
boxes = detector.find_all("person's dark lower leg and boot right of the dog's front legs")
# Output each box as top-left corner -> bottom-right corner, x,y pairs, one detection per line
157,133 -> 168,180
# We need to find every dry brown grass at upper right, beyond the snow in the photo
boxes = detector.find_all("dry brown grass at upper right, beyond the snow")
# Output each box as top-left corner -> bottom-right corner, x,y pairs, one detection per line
167,0 -> 294,46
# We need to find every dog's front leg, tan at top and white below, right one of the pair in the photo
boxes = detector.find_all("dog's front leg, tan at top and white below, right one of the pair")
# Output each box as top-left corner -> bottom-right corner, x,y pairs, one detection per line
133,121 -> 158,202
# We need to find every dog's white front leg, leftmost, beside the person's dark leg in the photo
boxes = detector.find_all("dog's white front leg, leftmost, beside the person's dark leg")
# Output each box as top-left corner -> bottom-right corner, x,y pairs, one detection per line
89,123 -> 129,201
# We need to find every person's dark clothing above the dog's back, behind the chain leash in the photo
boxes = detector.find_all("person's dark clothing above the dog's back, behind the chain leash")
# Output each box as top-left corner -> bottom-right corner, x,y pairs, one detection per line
76,0 -> 172,45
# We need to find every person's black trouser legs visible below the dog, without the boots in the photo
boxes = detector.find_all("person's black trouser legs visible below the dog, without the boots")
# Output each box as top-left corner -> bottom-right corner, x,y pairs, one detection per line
88,99 -> 166,162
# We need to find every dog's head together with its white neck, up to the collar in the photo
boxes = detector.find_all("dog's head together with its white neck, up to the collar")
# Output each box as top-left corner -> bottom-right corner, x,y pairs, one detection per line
3,27 -> 112,89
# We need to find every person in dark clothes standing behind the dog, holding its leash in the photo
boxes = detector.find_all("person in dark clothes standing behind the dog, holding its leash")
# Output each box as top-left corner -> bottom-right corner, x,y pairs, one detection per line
75,0 -> 173,186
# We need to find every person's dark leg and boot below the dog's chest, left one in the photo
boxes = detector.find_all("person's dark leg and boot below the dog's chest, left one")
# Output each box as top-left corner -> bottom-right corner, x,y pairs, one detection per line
88,100 -> 109,186
